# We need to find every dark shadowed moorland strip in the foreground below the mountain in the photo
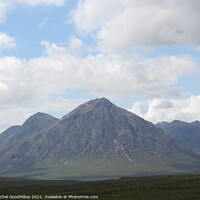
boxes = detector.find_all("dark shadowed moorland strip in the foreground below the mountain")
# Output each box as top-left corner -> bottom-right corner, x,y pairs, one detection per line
0,174 -> 200,200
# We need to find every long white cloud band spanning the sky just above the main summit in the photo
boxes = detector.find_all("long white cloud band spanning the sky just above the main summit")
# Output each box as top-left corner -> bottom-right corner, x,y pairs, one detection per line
0,41 -> 196,104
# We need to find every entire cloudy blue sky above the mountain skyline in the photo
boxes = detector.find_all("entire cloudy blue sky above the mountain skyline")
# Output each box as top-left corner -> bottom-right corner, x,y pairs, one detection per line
0,0 -> 200,130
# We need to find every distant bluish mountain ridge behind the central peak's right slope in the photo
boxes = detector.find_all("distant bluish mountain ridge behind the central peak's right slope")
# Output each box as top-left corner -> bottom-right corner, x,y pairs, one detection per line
156,120 -> 200,152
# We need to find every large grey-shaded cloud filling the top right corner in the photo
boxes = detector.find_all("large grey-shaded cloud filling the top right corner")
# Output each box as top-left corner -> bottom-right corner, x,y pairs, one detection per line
71,0 -> 200,52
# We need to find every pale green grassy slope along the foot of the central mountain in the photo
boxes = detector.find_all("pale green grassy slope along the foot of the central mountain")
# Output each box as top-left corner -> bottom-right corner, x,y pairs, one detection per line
0,153 -> 200,180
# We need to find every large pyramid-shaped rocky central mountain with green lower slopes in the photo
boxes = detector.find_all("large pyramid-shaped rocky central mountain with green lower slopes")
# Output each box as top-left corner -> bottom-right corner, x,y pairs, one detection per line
0,98 -> 200,179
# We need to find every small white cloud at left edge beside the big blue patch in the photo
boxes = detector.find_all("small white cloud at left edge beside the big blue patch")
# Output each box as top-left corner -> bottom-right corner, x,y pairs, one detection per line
0,32 -> 16,51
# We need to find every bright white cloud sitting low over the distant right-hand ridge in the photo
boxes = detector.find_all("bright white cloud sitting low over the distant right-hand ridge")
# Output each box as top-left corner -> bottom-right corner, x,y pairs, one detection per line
131,95 -> 200,123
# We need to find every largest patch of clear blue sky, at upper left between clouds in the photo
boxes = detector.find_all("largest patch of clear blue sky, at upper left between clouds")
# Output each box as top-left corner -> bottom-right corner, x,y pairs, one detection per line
1,3 -> 75,59
